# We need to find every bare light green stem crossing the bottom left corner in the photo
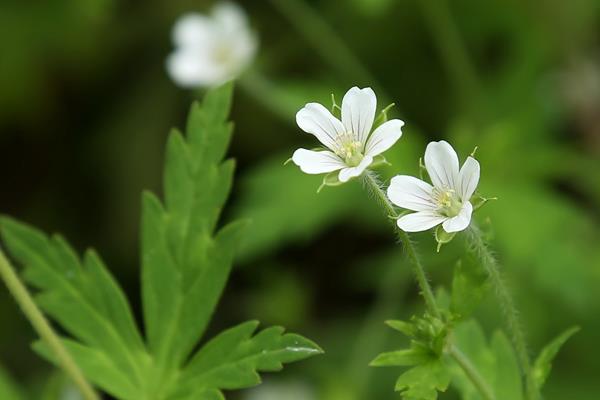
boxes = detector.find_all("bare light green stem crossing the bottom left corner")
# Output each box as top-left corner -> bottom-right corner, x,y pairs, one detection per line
0,249 -> 100,400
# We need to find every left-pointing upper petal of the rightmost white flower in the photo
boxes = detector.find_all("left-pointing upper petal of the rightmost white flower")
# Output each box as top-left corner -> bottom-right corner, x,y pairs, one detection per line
387,175 -> 436,211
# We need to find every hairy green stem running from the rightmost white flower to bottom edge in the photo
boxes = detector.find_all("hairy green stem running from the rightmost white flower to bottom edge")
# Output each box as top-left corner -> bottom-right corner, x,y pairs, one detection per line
467,224 -> 539,400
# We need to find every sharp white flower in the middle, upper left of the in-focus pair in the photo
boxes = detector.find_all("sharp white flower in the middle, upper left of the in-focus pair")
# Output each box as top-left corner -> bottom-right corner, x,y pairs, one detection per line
292,87 -> 404,182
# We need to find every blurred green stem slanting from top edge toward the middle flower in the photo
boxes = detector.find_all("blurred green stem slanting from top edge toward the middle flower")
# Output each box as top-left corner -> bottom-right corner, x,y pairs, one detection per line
270,0 -> 385,92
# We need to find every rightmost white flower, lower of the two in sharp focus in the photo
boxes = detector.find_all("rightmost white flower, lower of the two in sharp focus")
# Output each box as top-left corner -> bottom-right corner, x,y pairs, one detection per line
387,140 -> 479,233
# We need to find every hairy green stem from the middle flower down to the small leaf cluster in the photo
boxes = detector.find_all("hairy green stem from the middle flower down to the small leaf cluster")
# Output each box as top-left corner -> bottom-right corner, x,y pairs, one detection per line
364,171 -> 441,318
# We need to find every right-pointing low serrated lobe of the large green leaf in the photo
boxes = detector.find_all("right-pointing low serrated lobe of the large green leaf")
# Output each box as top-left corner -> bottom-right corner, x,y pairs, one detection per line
166,321 -> 322,398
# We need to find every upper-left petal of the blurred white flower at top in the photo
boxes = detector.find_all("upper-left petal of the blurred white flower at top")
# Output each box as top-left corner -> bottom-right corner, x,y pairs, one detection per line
173,13 -> 218,48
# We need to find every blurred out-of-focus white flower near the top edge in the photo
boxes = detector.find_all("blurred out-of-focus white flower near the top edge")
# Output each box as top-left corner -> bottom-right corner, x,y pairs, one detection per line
167,2 -> 258,88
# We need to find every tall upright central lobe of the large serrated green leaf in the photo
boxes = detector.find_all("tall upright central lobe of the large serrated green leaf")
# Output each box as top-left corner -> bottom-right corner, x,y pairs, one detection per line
142,85 -> 241,366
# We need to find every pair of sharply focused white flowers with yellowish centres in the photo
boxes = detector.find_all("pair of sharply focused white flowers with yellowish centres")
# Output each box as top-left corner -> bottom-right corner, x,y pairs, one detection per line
292,87 -> 480,233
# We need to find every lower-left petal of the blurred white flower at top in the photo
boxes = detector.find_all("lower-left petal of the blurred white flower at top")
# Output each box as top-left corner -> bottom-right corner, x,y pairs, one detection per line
167,50 -> 228,88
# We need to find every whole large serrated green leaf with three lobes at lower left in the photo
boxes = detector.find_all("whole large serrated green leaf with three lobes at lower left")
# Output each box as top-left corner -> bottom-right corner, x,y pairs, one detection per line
0,85 -> 321,400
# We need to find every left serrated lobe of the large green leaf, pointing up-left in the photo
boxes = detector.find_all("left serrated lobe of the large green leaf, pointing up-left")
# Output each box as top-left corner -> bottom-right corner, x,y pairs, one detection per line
0,218 -> 145,394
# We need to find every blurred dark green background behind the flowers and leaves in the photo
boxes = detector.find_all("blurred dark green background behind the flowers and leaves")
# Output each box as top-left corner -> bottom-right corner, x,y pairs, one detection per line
0,0 -> 600,400
